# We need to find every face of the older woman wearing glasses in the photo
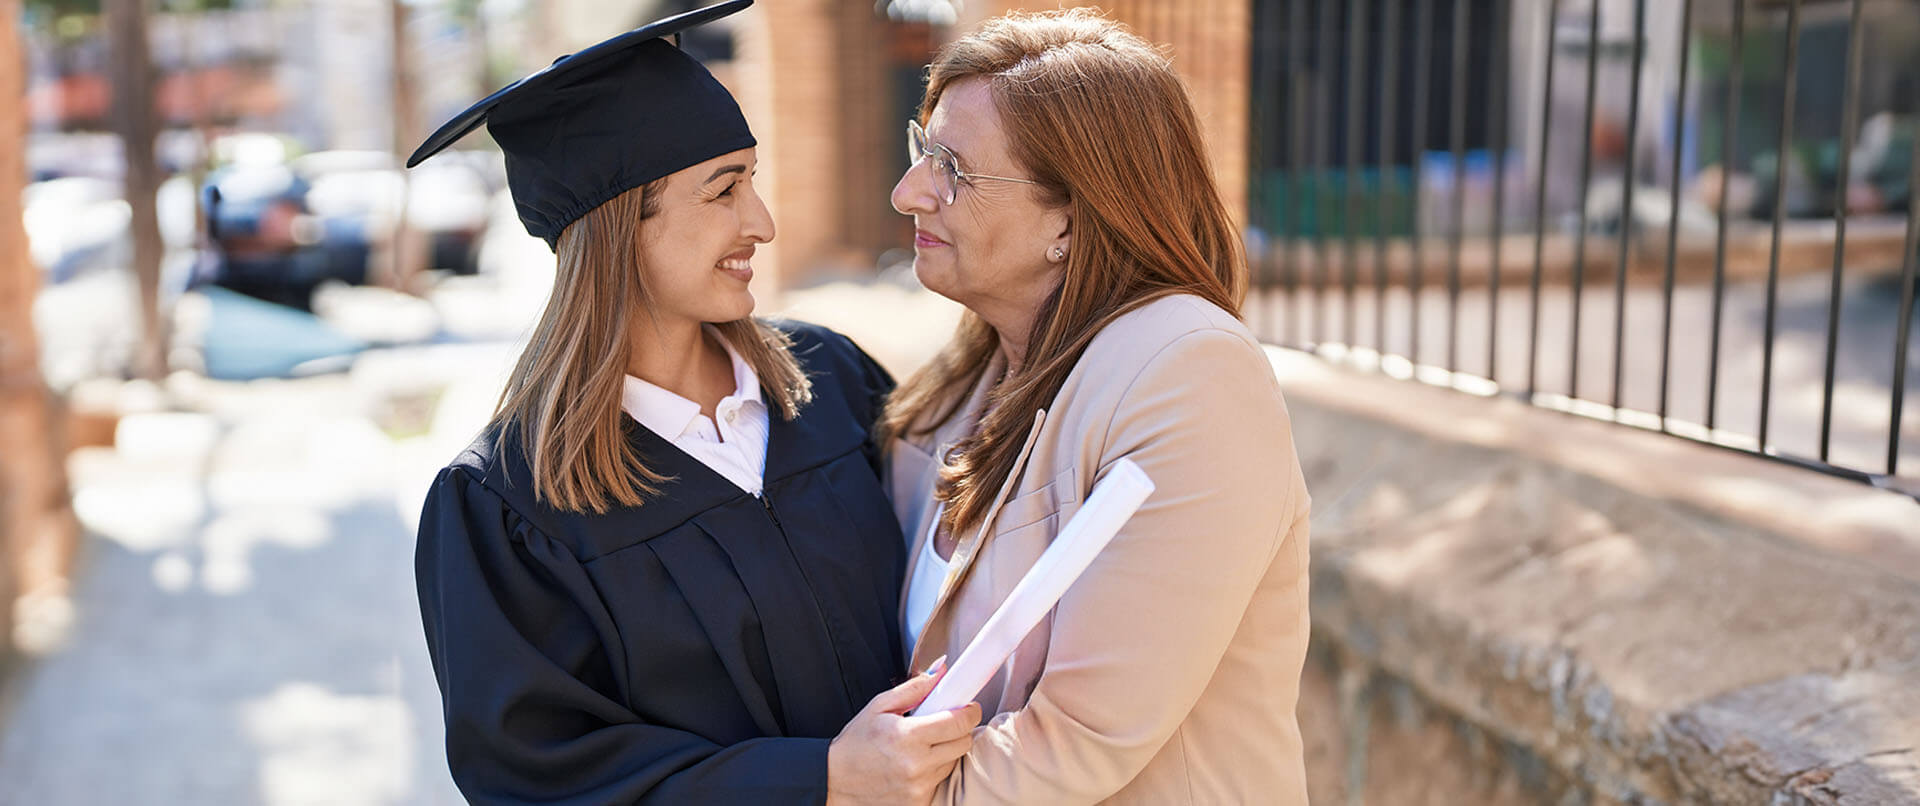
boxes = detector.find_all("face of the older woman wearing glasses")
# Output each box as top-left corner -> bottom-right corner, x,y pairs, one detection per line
893,79 -> 1069,331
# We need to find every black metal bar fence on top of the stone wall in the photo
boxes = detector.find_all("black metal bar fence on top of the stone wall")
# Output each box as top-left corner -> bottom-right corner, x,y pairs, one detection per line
1250,0 -> 1920,497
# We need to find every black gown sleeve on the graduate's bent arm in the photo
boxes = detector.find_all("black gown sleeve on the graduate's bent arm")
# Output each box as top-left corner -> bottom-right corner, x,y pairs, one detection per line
415,468 -> 828,804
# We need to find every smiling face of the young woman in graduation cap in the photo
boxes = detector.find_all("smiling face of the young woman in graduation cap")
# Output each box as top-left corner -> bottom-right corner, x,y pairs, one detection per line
639,148 -> 774,324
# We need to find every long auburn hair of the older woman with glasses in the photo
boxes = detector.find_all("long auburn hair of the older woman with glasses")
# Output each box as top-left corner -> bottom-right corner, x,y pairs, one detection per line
881,8 -> 1248,532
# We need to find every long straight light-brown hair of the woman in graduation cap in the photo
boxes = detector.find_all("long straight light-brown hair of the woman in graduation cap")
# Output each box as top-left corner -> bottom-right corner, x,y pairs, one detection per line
490,178 -> 812,514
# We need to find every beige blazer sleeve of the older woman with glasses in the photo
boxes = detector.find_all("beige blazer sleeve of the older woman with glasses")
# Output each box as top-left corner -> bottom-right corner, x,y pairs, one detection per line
935,330 -> 1308,804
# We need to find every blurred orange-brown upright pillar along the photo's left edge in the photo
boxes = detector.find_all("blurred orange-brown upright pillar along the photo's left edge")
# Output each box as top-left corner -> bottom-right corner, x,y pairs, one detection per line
0,0 -> 79,656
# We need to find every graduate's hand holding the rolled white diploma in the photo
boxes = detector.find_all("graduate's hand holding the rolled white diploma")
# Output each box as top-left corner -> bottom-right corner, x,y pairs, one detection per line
828,662 -> 981,806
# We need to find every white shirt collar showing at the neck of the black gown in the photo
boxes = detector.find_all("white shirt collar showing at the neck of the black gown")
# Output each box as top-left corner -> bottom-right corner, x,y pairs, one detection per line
620,324 -> 768,495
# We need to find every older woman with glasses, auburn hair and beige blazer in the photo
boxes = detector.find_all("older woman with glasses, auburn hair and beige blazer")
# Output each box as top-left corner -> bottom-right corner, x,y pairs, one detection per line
881,12 -> 1308,804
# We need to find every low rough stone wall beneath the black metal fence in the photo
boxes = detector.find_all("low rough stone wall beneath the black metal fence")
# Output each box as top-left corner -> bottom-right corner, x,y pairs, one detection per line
1275,351 -> 1920,804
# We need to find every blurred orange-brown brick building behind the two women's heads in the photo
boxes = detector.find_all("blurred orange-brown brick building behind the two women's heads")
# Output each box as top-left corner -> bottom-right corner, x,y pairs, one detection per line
722,0 -> 1250,286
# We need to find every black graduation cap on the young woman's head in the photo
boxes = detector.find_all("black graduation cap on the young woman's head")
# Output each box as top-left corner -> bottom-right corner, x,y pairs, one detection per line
407,0 -> 755,248
